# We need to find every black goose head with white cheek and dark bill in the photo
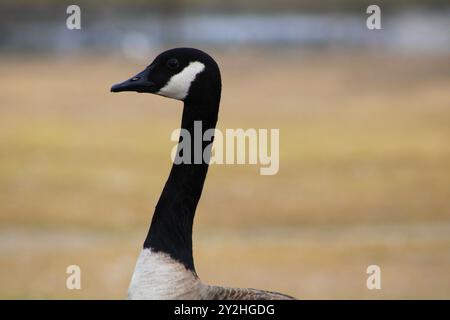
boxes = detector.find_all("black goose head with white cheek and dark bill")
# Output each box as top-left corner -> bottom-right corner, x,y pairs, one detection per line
111,48 -> 221,103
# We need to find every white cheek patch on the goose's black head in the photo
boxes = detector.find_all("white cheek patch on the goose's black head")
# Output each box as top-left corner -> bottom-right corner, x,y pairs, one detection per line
158,61 -> 205,100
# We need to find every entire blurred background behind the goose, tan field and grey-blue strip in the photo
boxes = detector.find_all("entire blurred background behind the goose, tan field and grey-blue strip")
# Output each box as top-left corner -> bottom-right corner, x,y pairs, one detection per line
0,0 -> 450,299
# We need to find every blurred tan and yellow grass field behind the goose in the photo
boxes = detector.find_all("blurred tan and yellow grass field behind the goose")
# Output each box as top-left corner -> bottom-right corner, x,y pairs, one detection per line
0,51 -> 450,299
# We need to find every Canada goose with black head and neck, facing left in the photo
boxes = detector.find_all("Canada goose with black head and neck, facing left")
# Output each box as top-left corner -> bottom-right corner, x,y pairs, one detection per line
111,48 -> 293,300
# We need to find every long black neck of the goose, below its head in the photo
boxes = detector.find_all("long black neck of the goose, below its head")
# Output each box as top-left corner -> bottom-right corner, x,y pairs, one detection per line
144,101 -> 219,272
